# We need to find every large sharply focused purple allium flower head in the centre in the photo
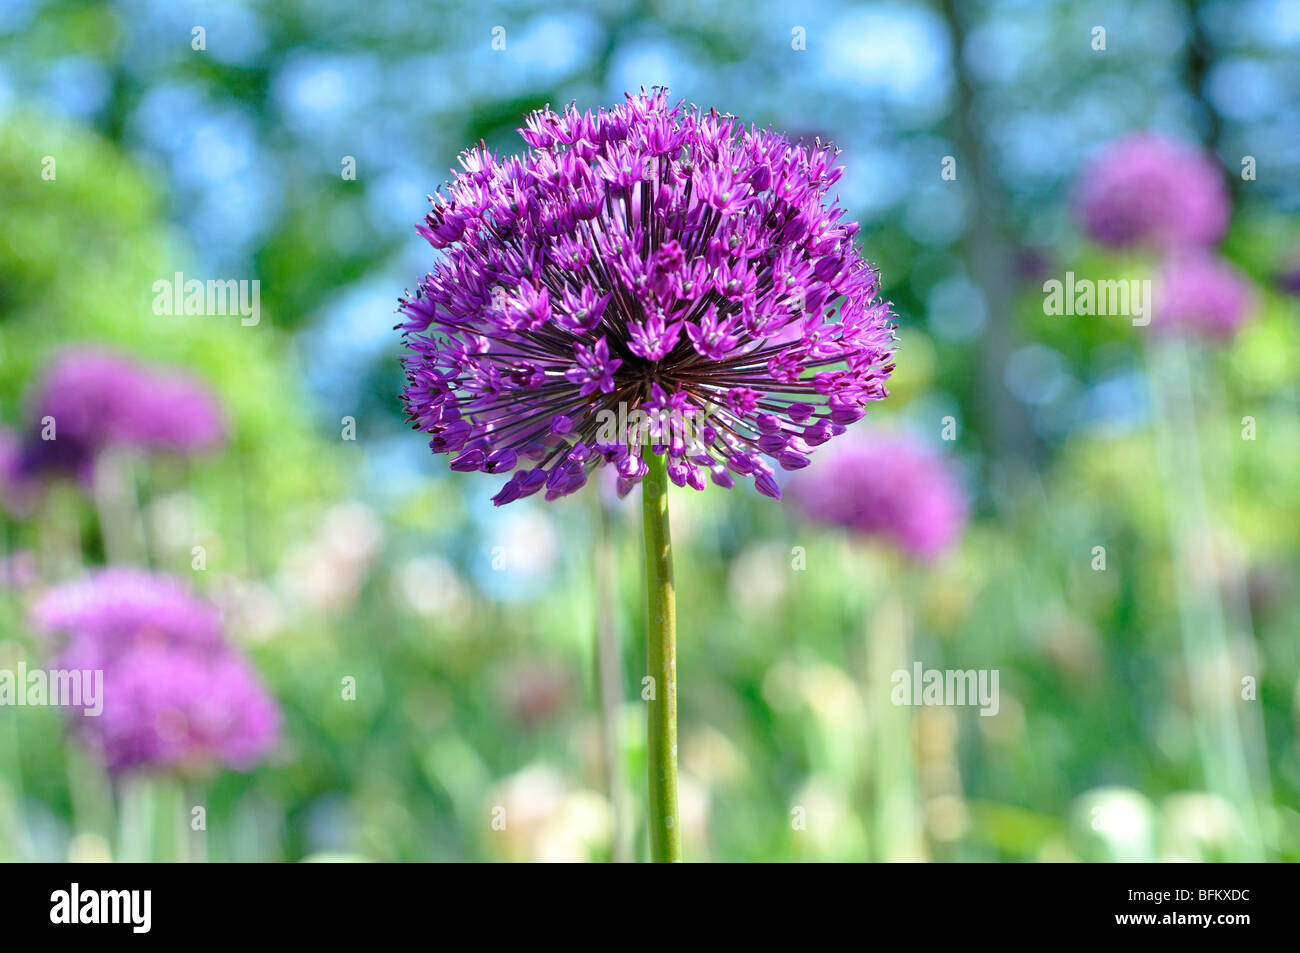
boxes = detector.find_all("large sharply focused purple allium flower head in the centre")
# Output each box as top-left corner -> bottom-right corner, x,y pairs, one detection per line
399,90 -> 894,506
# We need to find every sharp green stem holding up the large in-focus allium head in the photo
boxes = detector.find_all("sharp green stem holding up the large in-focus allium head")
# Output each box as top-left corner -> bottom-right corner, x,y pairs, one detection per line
641,454 -> 681,863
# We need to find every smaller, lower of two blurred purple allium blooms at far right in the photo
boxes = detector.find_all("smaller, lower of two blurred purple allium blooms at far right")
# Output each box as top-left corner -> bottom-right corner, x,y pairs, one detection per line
1153,251 -> 1252,341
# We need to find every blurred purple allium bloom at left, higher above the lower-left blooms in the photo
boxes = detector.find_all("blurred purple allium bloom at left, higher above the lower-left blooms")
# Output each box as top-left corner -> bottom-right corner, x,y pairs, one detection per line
21,350 -> 225,478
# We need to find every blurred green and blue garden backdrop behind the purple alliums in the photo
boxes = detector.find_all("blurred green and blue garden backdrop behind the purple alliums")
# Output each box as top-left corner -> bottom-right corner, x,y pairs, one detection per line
0,0 -> 1300,861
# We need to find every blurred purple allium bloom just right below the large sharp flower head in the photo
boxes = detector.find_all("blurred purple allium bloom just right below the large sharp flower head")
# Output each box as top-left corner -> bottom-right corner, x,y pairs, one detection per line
790,430 -> 967,560
